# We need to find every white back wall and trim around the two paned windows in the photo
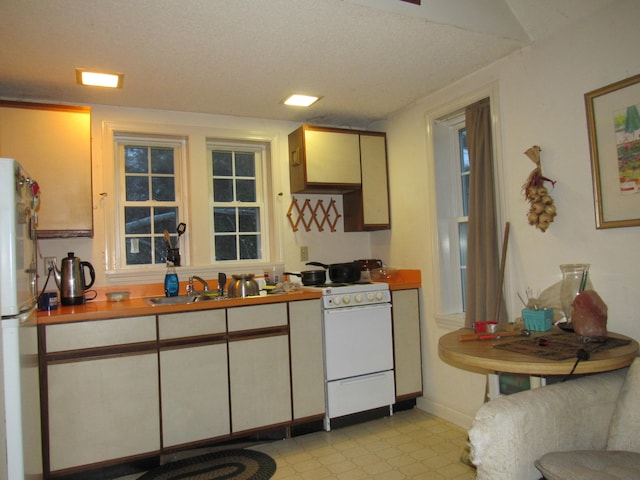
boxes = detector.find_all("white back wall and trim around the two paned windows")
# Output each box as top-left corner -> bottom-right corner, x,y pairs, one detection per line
40,105 -> 370,288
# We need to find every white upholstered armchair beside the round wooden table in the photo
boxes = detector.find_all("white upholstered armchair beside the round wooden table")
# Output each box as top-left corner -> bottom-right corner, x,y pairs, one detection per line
469,358 -> 640,480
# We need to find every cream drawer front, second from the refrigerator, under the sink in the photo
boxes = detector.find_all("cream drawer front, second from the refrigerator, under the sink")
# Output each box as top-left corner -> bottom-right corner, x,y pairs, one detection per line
158,308 -> 227,340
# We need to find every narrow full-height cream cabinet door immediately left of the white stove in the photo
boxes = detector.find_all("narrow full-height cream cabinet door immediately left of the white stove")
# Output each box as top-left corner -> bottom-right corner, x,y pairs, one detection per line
289,300 -> 324,420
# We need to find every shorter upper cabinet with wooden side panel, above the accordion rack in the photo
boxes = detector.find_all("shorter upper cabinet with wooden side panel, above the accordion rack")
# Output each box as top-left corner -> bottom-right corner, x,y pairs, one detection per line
289,125 -> 362,193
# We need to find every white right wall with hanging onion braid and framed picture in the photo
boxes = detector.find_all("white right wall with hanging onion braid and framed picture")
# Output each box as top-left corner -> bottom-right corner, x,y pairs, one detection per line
372,0 -> 640,425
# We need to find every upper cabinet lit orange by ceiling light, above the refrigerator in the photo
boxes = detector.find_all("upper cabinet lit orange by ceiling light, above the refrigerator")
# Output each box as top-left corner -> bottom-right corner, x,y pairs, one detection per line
0,101 -> 93,238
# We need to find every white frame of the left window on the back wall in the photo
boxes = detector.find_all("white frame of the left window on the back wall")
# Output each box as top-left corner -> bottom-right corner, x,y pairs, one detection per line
113,132 -> 189,271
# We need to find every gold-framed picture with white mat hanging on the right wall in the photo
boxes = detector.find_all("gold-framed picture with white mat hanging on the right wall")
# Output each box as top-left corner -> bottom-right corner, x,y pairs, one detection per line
584,74 -> 640,229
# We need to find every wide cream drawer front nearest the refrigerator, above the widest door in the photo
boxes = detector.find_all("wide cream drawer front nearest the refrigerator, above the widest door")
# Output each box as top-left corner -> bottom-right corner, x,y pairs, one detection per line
46,315 -> 156,352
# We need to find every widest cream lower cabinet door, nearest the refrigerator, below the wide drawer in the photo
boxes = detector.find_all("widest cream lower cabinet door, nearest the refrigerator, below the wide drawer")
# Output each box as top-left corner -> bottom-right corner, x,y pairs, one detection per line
48,353 -> 160,471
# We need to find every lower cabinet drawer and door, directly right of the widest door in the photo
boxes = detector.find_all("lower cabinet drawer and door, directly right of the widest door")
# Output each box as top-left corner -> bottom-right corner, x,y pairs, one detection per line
158,309 -> 230,448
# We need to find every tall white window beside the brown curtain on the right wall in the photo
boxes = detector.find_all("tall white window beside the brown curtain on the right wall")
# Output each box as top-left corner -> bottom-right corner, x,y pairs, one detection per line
433,112 -> 469,314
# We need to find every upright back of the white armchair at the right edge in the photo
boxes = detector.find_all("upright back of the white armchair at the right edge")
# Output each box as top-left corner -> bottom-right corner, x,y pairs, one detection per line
607,357 -> 640,452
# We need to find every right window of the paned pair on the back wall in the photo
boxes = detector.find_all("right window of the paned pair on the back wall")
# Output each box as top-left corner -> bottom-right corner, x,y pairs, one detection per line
207,142 -> 268,263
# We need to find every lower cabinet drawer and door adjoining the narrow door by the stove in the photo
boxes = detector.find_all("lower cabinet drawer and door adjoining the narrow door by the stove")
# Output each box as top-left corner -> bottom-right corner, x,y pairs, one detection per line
227,303 -> 291,433
